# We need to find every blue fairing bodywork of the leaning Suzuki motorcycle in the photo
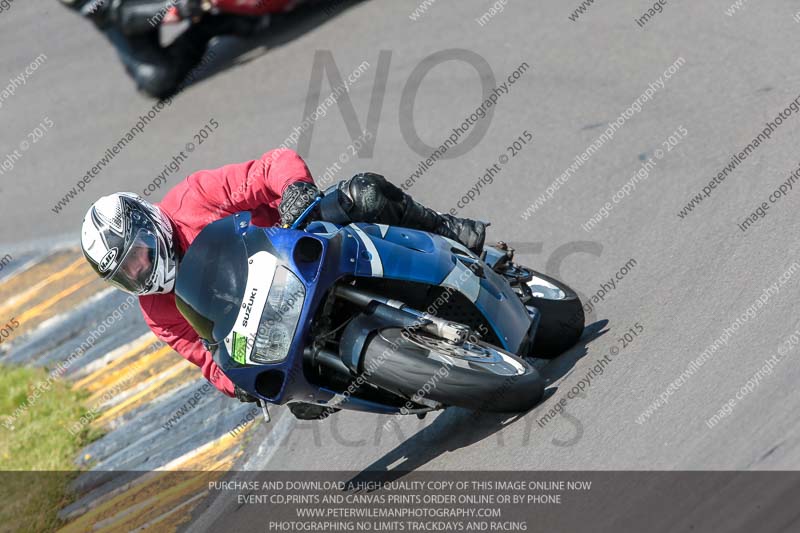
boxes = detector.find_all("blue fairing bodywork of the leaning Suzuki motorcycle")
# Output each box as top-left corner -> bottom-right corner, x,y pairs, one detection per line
176,213 -> 532,413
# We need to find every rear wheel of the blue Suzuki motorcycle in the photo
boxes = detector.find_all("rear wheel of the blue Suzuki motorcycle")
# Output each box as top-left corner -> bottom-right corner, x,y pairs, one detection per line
525,269 -> 585,359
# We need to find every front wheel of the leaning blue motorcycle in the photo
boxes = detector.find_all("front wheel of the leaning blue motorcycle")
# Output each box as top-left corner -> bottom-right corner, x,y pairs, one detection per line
363,328 -> 544,412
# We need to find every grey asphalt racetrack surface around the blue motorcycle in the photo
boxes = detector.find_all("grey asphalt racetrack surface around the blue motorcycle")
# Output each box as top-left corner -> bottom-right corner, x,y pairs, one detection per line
0,0 -> 800,523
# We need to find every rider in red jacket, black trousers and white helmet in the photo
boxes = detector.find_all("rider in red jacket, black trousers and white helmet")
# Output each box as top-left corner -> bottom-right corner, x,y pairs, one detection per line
81,149 -> 485,414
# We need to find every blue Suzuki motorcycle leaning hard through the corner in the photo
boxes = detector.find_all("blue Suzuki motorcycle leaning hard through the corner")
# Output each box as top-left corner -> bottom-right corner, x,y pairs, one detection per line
175,208 -> 584,419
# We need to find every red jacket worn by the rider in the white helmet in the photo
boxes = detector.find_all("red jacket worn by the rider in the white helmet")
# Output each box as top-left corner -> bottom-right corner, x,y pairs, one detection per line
139,149 -> 314,396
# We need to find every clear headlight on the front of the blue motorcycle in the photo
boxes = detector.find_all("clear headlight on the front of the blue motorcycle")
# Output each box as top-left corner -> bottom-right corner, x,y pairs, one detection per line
251,267 -> 306,363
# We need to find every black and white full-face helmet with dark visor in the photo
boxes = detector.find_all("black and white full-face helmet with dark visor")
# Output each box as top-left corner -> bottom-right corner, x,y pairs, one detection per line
81,192 -> 177,295
